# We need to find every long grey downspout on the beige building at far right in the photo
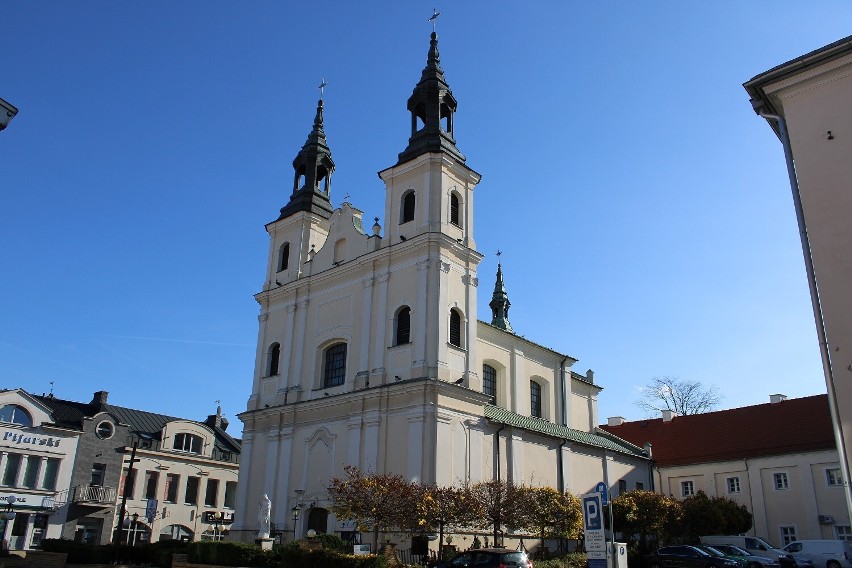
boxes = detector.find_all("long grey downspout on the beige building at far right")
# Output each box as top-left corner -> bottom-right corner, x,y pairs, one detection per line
752,104 -> 852,517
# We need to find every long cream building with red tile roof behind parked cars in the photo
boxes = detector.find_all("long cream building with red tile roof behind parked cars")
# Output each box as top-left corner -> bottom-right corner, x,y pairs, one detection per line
602,395 -> 852,546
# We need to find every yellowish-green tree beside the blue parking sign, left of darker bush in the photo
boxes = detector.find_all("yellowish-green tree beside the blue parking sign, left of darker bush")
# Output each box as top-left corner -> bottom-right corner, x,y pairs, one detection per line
612,489 -> 681,554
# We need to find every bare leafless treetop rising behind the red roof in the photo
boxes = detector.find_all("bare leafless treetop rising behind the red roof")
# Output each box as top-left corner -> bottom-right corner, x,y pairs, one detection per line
636,377 -> 724,415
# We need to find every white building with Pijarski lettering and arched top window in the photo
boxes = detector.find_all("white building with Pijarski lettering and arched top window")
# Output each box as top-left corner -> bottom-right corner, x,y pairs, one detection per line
0,389 -> 81,550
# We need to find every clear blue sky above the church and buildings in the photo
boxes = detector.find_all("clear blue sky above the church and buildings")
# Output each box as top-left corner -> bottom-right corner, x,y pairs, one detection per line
0,0 -> 852,432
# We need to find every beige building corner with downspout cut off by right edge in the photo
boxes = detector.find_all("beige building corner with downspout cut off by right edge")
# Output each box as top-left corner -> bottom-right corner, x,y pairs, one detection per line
744,36 -> 852,524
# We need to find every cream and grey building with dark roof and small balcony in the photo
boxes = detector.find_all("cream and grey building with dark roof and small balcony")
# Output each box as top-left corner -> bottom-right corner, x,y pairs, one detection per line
31,391 -> 240,544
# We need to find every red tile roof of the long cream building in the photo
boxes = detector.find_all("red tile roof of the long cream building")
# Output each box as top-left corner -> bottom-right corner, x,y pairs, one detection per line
601,394 -> 837,466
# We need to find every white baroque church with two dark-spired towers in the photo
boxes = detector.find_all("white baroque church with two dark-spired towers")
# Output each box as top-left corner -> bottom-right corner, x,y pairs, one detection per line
232,28 -> 652,540
